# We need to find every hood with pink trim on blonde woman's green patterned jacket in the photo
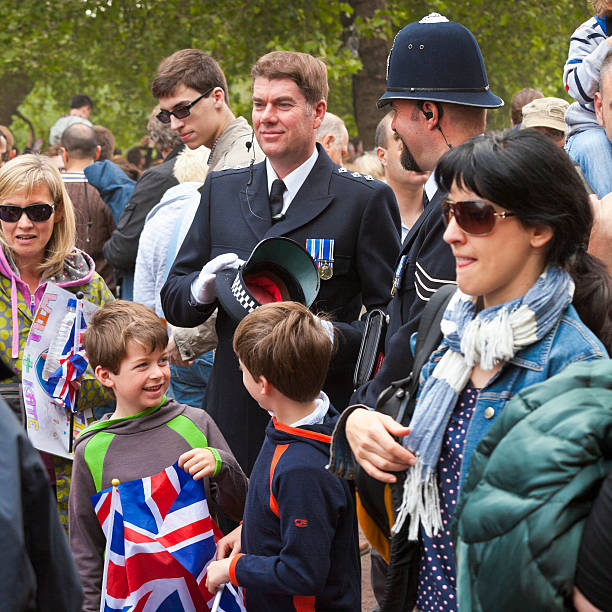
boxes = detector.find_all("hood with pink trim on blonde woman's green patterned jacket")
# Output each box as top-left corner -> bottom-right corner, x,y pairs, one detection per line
0,248 -> 96,359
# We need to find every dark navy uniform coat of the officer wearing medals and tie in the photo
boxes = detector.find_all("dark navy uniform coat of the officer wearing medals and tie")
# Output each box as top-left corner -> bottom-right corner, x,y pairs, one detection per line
161,145 -> 400,473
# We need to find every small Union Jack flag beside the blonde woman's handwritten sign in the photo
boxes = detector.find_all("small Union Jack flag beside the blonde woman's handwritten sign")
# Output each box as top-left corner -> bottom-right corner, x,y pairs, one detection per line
45,300 -> 88,413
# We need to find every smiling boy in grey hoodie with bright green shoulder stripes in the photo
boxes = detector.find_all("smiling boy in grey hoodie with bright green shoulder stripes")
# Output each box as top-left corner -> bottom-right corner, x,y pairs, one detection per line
70,301 -> 247,612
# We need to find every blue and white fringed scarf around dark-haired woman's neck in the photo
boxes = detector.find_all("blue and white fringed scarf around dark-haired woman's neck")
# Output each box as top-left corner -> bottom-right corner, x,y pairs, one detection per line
392,267 -> 574,540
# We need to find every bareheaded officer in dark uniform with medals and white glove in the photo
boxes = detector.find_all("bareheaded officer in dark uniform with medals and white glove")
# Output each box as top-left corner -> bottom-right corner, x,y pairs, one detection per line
161,51 -> 400,473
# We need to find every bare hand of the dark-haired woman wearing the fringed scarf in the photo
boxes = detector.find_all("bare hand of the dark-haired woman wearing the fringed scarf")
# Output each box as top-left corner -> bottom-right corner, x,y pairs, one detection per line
346,408 -> 416,483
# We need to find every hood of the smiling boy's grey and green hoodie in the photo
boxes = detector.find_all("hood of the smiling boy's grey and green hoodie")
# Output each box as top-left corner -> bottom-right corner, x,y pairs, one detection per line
75,396 -> 180,449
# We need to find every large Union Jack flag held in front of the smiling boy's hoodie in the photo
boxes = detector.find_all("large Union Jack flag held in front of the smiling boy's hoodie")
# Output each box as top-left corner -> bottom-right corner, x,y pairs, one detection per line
91,463 -> 246,612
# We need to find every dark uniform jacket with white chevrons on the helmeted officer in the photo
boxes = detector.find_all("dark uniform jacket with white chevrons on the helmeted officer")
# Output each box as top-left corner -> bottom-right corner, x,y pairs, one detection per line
350,190 -> 455,407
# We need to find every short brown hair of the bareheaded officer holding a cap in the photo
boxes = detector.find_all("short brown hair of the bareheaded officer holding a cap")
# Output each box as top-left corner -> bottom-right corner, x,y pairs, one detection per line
251,51 -> 329,105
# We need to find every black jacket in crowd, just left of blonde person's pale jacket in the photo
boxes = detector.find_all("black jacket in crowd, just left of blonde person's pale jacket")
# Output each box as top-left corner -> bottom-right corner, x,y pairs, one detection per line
104,145 -> 184,276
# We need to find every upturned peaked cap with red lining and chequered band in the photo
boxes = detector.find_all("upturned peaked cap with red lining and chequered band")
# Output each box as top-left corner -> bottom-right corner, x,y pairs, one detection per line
215,236 -> 320,322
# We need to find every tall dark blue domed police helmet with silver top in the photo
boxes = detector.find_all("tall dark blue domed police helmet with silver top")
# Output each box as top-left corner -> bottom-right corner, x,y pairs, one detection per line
378,13 -> 504,108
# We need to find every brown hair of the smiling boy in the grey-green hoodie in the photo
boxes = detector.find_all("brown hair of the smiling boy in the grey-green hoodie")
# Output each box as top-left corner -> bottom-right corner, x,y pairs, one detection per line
83,300 -> 168,374
